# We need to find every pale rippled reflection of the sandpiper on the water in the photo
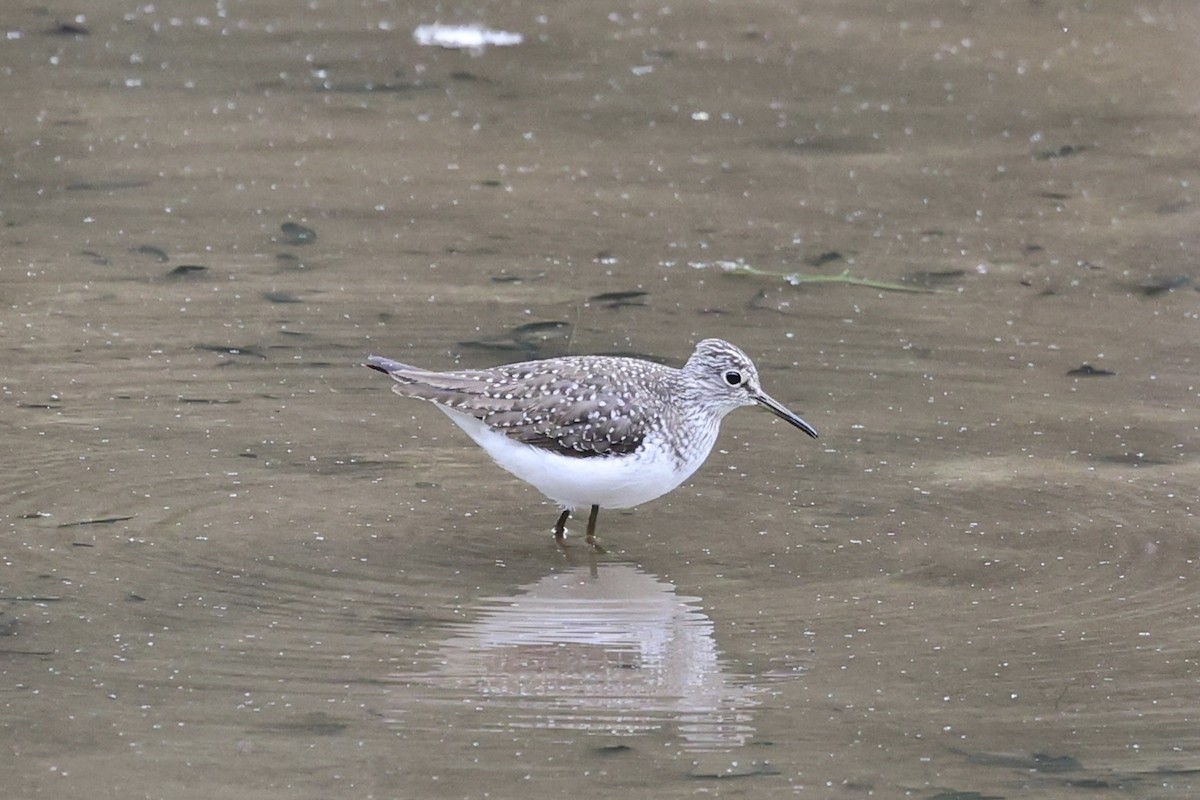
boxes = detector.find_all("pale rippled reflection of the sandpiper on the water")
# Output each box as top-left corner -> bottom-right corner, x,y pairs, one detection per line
397,564 -> 757,750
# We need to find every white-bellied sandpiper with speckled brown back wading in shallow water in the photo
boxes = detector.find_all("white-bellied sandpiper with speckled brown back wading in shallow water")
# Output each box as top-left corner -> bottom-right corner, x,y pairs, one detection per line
366,339 -> 817,542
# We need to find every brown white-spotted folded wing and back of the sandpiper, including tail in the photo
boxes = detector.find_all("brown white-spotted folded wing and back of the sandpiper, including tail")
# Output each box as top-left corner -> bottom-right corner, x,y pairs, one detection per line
367,356 -> 670,458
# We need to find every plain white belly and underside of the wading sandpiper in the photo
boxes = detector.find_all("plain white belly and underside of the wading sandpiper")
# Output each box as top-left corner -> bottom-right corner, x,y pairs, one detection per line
438,405 -> 716,509
